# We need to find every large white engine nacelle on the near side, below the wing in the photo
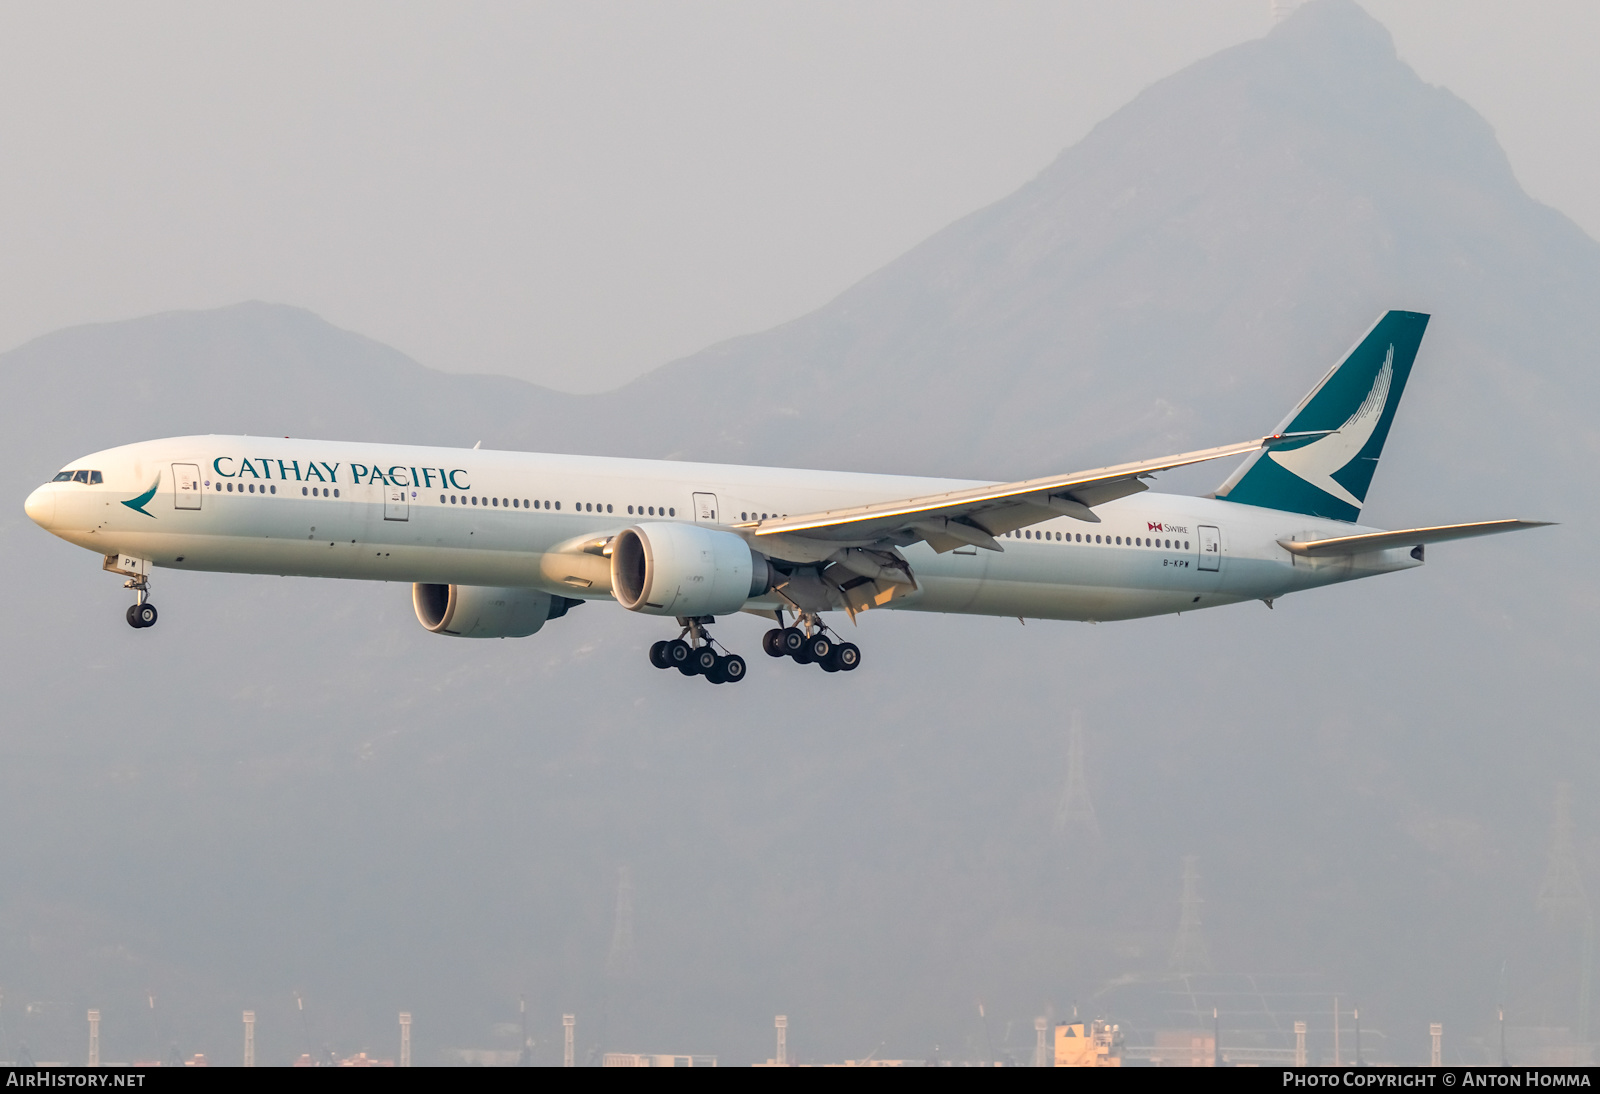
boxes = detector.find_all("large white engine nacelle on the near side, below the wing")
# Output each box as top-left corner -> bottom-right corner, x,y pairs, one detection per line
611,523 -> 773,616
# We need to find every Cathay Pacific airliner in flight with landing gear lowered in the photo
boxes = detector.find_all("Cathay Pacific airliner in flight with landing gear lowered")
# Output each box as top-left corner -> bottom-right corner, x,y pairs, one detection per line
26,310 -> 1547,683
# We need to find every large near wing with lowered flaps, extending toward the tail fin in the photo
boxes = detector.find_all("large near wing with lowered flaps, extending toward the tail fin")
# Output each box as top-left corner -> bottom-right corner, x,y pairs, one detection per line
734,430 -> 1326,557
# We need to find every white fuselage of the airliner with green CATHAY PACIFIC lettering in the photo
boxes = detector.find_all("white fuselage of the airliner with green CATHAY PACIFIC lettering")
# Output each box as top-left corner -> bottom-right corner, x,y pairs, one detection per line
27,437 -> 1419,621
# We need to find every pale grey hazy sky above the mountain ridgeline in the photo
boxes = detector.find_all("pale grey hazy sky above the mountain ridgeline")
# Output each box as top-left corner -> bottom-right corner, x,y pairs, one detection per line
0,0 -> 1600,390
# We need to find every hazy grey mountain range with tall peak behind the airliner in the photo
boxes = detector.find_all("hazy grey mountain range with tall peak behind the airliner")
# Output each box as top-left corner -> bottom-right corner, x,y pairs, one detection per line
0,0 -> 1600,1062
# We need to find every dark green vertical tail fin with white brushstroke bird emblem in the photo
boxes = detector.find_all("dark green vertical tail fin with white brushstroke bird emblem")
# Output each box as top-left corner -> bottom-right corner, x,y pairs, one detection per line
1216,312 -> 1427,521
